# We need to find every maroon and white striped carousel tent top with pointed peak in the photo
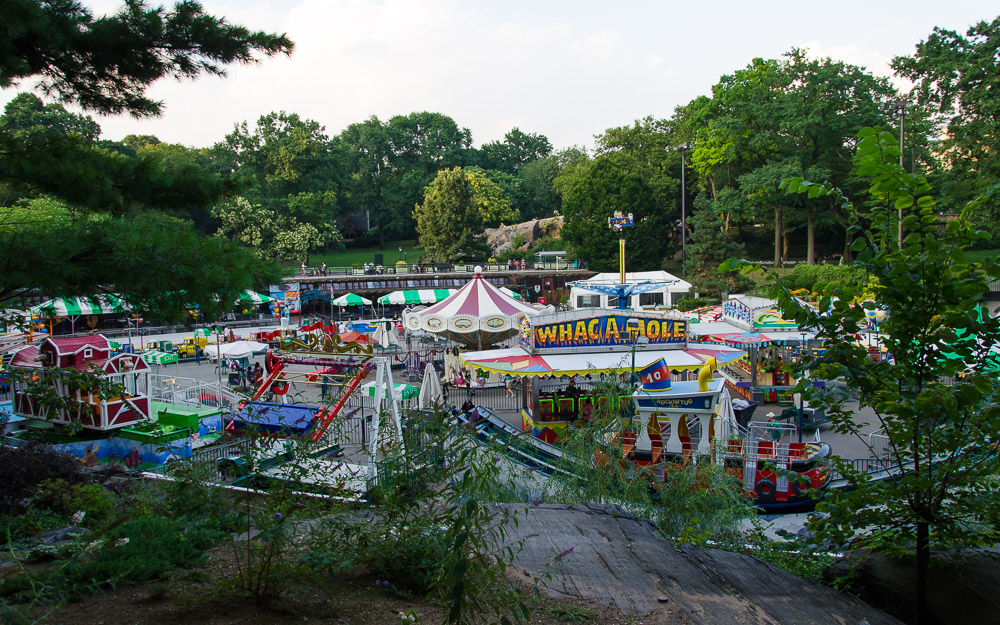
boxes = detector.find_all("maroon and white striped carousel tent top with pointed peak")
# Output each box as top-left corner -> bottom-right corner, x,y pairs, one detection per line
403,267 -> 551,346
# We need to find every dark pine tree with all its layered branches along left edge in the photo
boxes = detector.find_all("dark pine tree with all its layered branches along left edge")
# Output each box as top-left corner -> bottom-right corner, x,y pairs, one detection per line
0,0 -> 292,318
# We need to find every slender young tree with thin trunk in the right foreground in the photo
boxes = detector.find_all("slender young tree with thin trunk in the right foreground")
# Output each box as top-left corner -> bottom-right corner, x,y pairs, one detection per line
740,129 -> 1000,623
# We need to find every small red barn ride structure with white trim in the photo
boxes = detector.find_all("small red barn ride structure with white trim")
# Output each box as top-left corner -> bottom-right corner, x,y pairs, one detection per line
9,334 -> 150,431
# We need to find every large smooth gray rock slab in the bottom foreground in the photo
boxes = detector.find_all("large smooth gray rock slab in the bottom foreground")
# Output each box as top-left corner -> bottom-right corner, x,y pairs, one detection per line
506,504 -> 901,625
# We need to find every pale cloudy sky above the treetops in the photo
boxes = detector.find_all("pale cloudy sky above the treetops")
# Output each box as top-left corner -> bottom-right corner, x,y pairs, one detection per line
0,0 -> 1000,150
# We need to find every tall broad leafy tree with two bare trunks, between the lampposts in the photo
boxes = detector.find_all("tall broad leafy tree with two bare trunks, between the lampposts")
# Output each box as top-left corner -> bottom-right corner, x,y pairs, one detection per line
684,50 -> 896,263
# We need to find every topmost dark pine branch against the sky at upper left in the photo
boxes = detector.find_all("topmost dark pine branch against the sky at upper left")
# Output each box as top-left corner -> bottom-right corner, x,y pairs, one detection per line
0,0 -> 293,117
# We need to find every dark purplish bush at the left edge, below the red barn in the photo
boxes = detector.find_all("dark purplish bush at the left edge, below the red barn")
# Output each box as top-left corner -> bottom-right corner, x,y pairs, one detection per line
0,443 -> 89,513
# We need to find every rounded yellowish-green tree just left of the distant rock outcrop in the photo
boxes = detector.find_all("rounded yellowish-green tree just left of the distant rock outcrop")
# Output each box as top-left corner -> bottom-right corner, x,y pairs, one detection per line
413,167 -> 487,262
